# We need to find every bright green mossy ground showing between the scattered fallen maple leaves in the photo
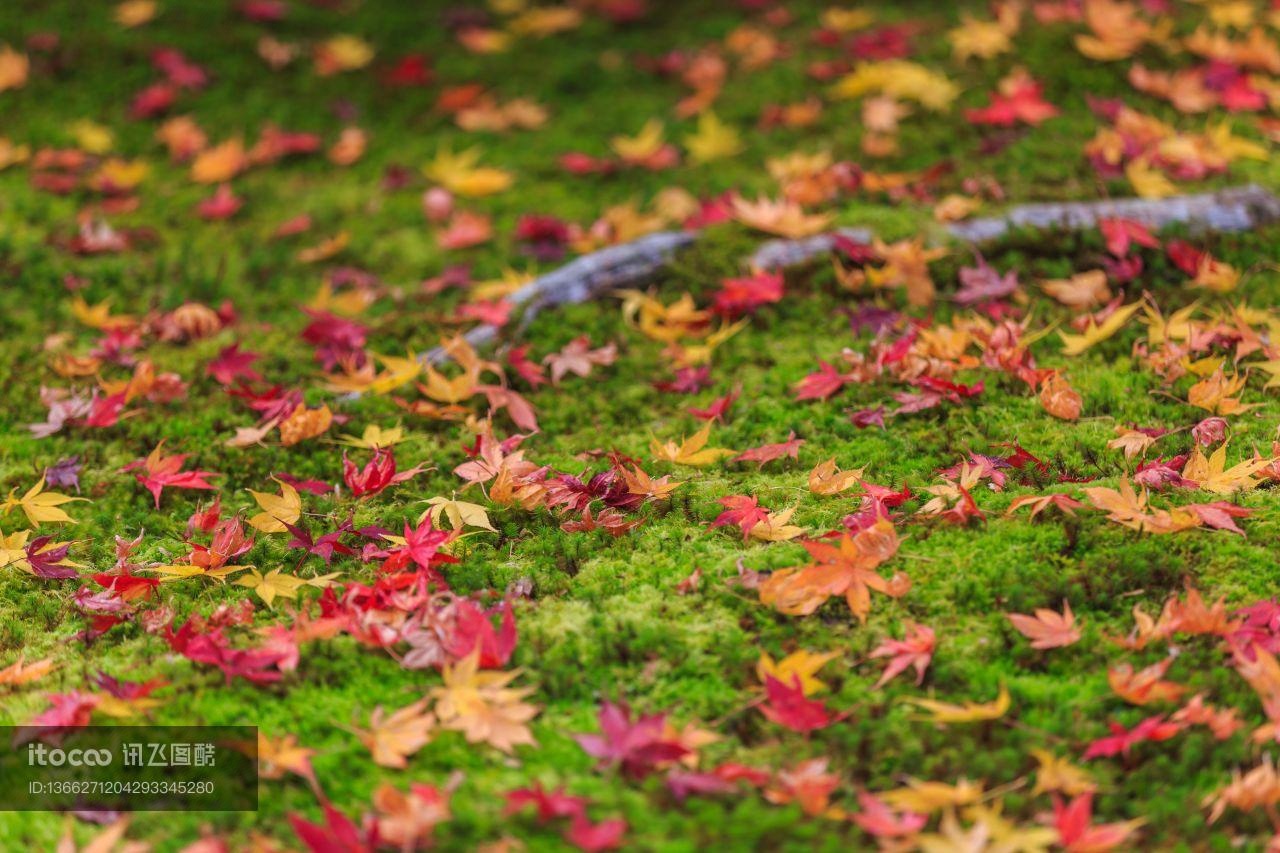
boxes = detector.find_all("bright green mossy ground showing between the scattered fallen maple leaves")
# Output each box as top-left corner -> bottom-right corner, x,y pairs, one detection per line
0,0 -> 1280,850
